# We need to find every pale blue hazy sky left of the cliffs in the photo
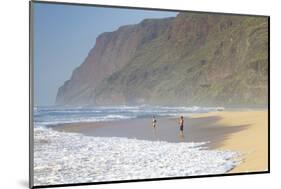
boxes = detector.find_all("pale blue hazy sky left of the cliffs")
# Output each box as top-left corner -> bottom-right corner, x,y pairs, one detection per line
33,3 -> 177,105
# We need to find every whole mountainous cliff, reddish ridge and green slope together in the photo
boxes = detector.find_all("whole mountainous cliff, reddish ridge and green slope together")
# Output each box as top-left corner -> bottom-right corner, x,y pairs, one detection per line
56,13 -> 268,105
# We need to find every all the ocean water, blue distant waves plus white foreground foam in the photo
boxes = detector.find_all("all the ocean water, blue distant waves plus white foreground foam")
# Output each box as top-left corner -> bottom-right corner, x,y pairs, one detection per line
34,106 -> 240,185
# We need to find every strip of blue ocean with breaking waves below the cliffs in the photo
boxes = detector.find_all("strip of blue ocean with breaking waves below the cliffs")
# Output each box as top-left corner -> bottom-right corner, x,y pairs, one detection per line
34,105 -> 221,126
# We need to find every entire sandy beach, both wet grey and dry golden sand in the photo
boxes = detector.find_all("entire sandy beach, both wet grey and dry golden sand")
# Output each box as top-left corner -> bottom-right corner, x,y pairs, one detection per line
51,110 -> 268,173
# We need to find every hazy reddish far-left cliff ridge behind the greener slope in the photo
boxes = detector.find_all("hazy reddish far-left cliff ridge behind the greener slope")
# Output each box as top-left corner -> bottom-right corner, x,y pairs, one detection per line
56,18 -> 171,105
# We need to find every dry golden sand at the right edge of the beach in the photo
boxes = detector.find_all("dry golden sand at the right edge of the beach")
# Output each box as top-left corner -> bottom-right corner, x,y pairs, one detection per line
192,111 -> 268,173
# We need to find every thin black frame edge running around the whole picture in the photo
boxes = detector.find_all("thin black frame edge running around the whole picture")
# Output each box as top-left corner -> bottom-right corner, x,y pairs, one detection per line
29,0 -> 270,188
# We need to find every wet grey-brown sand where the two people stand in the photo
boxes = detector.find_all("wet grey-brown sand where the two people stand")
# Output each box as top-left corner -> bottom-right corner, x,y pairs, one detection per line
49,116 -> 246,149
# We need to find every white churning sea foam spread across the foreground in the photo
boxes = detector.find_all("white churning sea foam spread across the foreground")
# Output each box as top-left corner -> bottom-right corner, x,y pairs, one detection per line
34,127 -> 239,185
